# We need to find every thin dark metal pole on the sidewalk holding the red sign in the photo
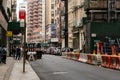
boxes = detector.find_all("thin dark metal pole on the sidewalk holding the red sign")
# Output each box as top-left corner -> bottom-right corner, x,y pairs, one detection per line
23,19 -> 26,72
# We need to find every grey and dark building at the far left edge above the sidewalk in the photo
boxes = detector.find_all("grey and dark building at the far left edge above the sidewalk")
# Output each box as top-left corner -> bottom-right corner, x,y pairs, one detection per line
0,0 -> 11,45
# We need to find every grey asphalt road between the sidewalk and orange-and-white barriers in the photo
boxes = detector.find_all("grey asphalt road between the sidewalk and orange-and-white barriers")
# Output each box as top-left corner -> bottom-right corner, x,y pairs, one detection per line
30,55 -> 120,80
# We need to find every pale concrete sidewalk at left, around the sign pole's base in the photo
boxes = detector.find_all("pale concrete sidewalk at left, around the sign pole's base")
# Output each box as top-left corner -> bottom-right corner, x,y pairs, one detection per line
0,57 -> 40,80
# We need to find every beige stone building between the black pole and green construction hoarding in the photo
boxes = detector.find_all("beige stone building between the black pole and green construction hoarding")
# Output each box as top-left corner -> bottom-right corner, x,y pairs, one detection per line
68,0 -> 86,50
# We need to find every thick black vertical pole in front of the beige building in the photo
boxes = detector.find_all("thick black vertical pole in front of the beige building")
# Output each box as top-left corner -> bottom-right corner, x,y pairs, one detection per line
64,0 -> 68,47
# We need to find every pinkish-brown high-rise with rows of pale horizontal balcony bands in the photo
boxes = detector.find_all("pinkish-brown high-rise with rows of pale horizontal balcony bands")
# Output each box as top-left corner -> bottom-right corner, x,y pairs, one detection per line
27,0 -> 44,43
